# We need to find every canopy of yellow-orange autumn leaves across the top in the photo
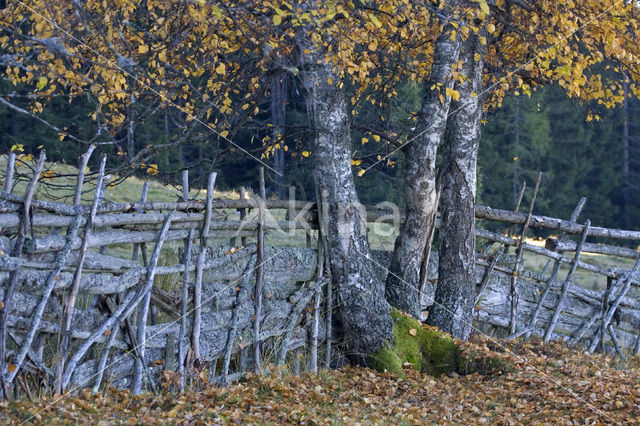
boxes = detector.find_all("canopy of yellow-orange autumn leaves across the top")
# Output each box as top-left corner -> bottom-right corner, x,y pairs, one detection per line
0,0 -> 640,175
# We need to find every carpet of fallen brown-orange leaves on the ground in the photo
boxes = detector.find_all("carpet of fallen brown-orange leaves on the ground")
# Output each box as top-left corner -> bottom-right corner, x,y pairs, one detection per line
0,337 -> 640,425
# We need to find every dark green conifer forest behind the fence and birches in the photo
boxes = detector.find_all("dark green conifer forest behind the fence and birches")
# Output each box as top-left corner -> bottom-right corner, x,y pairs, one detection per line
0,74 -> 640,233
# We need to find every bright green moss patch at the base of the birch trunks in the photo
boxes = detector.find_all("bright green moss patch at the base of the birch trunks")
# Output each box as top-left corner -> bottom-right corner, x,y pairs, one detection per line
371,309 -> 510,378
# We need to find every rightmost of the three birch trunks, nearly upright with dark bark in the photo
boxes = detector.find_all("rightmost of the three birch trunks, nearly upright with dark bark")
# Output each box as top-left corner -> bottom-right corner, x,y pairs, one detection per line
427,31 -> 484,340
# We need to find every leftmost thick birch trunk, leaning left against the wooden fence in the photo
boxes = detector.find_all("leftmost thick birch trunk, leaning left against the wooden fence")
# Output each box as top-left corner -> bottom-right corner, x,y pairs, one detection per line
299,30 -> 393,364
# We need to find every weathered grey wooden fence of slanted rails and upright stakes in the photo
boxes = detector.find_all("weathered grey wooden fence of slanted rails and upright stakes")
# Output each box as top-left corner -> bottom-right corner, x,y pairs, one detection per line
0,149 -> 640,393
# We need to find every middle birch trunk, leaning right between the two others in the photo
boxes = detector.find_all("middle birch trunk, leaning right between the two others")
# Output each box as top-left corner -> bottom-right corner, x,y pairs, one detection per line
385,6 -> 460,318
